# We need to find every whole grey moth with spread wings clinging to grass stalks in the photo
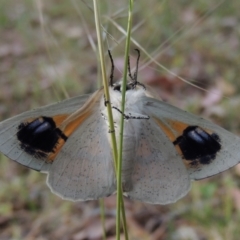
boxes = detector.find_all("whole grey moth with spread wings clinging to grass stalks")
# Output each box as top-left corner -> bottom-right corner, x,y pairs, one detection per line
0,49 -> 240,204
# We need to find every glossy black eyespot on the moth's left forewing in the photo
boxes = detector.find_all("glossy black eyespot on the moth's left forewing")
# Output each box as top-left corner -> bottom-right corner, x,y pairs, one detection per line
17,117 -> 67,158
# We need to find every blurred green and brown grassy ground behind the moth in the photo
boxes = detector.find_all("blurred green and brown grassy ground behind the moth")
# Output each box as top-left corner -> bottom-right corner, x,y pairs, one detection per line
0,0 -> 240,240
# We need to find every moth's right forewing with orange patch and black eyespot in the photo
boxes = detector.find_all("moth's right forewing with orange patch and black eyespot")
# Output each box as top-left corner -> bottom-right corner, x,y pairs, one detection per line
143,97 -> 240,180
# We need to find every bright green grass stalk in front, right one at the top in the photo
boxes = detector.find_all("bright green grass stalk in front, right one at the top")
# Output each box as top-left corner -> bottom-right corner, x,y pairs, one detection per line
116,0 -> 133,240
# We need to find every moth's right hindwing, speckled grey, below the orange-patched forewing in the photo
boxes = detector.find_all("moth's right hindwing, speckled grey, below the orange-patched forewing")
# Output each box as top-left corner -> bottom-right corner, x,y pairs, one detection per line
126,118 -> 190,204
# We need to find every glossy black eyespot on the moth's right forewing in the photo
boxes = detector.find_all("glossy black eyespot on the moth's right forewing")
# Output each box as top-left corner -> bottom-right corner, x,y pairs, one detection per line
173,126 -> 221,165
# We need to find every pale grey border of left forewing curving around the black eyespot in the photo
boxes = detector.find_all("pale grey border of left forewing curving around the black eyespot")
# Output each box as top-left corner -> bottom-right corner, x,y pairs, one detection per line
0,95 -> 89,171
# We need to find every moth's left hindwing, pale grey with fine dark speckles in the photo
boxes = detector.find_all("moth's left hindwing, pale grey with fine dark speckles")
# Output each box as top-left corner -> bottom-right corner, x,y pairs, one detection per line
47,111 -> 116,201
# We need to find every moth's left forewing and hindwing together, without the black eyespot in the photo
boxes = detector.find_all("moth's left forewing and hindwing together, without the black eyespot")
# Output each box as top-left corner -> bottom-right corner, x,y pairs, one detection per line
0,91 -> 116,200
